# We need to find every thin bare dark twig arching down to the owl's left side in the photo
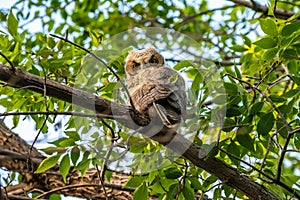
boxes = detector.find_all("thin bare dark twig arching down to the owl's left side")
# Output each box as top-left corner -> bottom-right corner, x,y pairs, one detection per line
50,34 -> 136,111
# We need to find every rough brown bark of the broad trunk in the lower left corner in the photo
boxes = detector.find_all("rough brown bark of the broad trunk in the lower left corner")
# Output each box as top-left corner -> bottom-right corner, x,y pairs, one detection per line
0,121 -> 133,200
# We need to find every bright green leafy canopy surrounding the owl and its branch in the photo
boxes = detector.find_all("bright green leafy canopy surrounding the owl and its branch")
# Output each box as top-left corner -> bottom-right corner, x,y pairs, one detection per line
0,0 -> 300,199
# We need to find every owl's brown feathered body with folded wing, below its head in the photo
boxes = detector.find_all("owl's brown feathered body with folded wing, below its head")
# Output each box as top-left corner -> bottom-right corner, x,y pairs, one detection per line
130,67 -> 186,127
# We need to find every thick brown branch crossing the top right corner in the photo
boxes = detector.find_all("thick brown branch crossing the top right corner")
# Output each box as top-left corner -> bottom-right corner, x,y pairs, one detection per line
228,0 -> 300,20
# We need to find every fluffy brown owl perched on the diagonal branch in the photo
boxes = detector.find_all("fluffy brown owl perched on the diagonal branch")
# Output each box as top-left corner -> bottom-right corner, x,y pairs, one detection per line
125,47 -> 186,128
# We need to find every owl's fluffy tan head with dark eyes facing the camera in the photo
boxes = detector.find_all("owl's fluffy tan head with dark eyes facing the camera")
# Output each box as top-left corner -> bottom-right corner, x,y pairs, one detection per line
125,46 -> 165,76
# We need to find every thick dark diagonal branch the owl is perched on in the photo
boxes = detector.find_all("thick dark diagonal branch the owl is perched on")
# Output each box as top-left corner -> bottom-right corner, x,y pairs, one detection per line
0,64 -> 278,200
